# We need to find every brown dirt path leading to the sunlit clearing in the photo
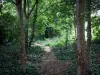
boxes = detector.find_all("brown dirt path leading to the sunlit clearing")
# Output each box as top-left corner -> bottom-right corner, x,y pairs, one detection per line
35,43 -> 71,75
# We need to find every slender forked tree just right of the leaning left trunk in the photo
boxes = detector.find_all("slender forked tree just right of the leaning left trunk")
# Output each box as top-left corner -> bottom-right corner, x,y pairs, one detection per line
24,0 -> 36,50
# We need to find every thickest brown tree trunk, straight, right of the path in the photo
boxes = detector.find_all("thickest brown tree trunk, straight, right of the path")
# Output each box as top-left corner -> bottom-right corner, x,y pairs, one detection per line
76,0 -> 86,75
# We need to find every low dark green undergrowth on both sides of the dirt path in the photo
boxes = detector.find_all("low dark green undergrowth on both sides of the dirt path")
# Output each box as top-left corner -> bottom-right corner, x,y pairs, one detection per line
0,38 -> 100,75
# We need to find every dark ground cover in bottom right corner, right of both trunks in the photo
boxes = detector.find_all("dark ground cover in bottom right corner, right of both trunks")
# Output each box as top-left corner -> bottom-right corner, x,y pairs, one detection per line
91,42 -> 100,75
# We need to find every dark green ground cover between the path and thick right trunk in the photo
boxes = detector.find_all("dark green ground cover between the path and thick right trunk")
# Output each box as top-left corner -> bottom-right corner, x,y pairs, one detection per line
53,44 -> 77,75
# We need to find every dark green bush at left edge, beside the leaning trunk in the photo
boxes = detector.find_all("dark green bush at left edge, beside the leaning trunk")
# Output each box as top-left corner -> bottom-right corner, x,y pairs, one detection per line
0,13 -> 19,42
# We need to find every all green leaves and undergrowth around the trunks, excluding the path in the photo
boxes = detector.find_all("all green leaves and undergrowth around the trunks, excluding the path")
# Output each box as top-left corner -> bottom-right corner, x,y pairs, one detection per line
0,0 -> 100,75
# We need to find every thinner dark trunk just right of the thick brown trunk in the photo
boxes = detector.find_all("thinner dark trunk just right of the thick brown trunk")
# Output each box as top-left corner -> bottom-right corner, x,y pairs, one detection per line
86,0 -> 91,72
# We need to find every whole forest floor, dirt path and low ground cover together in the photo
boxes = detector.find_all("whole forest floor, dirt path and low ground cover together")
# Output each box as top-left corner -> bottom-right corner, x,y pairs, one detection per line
0,40 -> 100,75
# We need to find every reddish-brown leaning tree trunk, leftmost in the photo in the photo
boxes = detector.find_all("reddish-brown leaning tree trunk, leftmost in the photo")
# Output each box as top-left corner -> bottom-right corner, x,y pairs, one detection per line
16,0 -> 26,75
